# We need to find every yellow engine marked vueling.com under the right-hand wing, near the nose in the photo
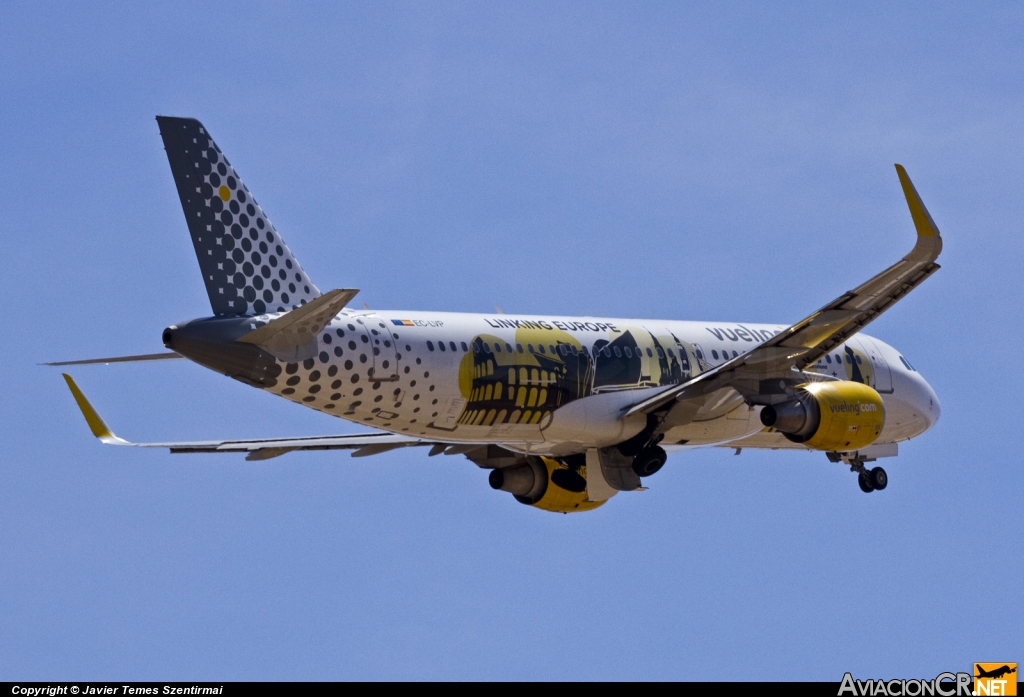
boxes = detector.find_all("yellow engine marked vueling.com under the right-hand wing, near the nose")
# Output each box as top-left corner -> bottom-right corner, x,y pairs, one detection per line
761,380 -> 886,451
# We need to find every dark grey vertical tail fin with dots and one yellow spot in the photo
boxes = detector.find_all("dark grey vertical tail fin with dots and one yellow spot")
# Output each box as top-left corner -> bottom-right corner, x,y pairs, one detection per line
157,117 -> 321,316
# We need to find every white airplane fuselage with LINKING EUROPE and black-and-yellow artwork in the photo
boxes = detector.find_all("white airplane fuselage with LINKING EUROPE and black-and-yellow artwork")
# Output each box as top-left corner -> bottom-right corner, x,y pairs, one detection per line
253,309 -> 940,455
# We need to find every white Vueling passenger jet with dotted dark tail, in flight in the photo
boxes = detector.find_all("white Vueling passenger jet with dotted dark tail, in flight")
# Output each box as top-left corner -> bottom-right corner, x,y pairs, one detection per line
47,117 -> 942,513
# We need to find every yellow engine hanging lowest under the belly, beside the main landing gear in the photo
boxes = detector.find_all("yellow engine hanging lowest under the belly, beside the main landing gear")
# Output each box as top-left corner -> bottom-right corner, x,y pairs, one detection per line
488,455 -> 604,513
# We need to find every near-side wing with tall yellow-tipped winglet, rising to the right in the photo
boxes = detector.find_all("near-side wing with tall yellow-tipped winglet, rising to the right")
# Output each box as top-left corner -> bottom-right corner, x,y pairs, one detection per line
624,165 -> 942,416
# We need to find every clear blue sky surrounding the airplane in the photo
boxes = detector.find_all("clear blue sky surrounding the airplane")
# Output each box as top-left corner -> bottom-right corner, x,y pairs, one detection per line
0,2 -> 1024,681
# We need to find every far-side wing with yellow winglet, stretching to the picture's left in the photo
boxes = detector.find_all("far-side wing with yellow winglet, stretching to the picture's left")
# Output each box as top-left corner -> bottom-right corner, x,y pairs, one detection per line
63,374 -> 444,461
